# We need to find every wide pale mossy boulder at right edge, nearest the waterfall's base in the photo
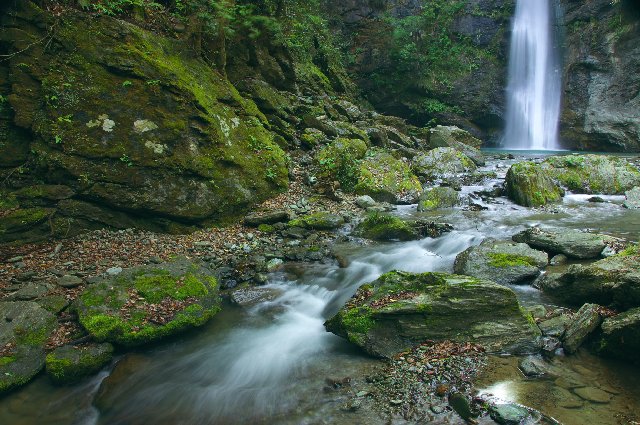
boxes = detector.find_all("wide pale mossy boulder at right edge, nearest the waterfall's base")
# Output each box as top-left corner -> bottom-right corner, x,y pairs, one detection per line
541,155 -> 640,195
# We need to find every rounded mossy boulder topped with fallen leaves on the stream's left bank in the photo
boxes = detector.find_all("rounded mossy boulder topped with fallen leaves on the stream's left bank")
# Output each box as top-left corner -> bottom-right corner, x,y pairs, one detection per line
76,260 -> 220,347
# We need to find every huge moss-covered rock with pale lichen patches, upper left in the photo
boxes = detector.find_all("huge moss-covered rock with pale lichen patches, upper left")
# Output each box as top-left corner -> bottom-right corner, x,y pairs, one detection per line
0,1 -> 288,234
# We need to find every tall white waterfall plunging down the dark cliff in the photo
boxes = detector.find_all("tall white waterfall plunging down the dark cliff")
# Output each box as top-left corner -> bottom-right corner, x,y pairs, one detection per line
503,0 -> 561,150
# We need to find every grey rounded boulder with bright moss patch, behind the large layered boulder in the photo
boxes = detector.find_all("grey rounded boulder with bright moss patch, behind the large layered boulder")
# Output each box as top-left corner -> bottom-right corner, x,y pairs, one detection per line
453,239 -> 549,285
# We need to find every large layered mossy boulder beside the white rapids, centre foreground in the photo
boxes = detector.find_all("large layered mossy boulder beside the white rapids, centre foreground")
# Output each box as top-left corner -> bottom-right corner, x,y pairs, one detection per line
325,271 -> 539,357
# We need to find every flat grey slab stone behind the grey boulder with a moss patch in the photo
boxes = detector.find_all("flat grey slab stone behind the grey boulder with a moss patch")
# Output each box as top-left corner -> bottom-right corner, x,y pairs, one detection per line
512,227 -> 619,259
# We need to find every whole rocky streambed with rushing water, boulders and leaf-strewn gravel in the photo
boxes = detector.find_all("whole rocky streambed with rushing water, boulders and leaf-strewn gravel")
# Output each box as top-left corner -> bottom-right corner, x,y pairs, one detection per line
0,152 -> 640,424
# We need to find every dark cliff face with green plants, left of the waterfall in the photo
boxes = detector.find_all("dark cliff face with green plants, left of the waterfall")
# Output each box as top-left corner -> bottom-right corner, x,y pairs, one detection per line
327,0 -> 515,138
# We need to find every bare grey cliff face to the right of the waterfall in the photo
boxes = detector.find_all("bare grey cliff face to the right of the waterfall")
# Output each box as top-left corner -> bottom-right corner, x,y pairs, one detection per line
560,0 -> 640,152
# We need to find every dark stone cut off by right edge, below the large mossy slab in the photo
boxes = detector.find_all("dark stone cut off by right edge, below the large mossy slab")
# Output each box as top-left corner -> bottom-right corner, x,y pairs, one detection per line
598,308 -> 640,363
